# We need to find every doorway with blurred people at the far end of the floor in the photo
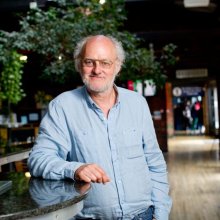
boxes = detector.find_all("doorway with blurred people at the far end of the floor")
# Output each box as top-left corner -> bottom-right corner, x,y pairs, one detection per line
172,81 -> 219,135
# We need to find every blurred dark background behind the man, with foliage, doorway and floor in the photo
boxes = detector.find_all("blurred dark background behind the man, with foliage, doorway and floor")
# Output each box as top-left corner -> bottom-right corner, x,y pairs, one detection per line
0,0 -> 220,220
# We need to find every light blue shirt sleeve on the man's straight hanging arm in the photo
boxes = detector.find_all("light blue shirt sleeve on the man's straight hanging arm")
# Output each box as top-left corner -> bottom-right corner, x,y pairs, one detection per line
143,100 -> 172,220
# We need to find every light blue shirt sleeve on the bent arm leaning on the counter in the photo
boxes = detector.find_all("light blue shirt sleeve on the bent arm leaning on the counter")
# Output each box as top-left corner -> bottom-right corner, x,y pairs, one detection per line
28,101 -> 83,180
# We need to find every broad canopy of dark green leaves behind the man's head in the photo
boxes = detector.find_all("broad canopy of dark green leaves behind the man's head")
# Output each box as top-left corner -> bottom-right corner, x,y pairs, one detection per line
1,0 -> 176,87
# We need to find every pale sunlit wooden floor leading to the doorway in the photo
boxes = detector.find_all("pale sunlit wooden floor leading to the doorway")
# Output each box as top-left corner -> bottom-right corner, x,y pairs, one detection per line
165,136 -> 220,220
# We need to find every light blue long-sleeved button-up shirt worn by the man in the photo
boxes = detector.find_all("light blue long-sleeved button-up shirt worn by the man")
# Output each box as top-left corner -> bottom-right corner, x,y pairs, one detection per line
28,87 -> 171,220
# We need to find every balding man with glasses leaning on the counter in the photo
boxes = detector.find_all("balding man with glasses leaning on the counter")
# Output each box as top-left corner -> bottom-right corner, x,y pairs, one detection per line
28,35 -> 171,220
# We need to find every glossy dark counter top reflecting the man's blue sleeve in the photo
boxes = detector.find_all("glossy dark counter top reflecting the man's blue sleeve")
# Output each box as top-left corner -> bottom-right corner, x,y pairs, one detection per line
0,172 -> 90,220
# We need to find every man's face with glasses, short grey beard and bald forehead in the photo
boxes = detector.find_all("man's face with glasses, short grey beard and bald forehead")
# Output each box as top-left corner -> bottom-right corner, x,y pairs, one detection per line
81,37 -> 120,93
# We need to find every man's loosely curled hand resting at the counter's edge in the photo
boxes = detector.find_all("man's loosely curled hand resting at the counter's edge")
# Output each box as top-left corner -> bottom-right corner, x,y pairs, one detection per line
74,164 -> 110,183
